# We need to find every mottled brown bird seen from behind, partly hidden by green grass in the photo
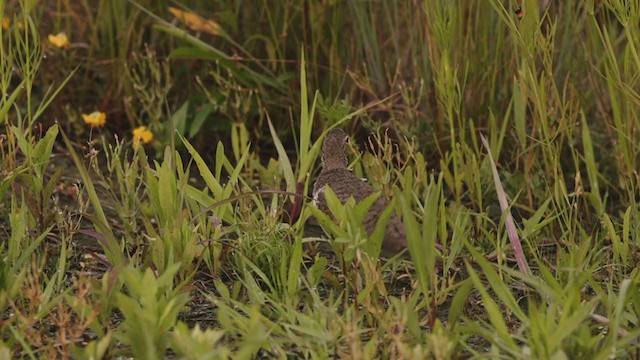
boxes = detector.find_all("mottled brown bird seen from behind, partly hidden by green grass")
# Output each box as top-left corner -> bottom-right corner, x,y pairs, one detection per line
313,128 -> 407,256
